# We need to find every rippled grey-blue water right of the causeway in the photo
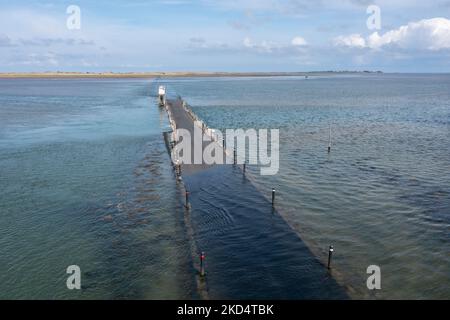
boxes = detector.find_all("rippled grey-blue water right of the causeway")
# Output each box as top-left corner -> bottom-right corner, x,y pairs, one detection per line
165,75 -> 450,299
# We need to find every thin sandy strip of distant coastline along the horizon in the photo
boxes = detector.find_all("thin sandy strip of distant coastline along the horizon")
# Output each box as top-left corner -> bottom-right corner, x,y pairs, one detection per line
0,71 -> 382,78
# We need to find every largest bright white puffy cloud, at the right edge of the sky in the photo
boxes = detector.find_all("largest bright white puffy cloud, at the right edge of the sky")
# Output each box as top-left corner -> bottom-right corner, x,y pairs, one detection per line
334,18 -> 450,51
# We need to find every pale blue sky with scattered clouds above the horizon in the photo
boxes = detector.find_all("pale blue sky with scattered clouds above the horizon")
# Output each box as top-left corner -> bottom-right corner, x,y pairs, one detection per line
0,0 -> 450,72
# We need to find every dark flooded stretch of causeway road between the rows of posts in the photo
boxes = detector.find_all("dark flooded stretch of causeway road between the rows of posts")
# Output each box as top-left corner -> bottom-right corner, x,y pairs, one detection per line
166,99 -> 348,299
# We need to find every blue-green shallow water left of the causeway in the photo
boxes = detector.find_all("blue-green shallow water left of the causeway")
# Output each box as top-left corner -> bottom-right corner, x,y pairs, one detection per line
0,79 -> 197,299
